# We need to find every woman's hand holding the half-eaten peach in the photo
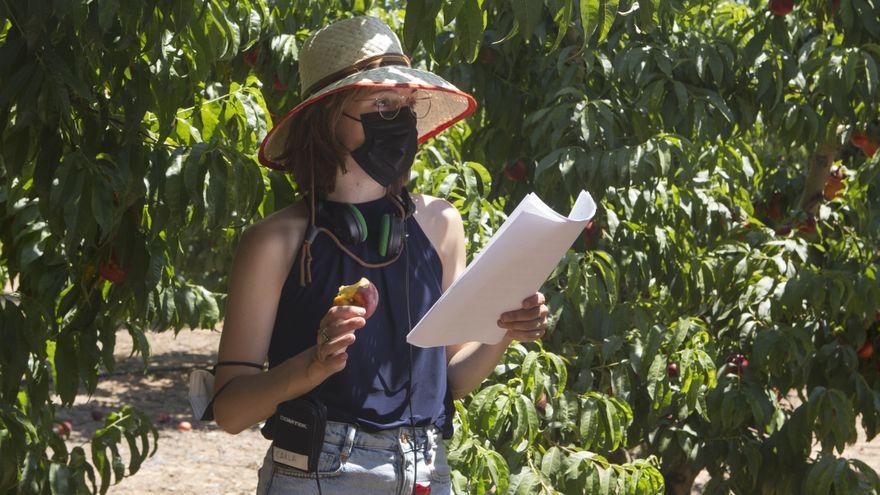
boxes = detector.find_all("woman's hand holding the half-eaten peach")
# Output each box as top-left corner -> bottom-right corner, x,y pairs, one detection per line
308,306 -> 367,382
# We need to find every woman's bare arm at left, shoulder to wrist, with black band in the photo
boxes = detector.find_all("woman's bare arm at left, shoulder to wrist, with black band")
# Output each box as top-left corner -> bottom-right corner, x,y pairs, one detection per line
213,209 -> 324,434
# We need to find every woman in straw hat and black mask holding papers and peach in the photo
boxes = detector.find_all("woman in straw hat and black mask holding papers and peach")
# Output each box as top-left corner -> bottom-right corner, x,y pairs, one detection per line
213,17 -> 547,495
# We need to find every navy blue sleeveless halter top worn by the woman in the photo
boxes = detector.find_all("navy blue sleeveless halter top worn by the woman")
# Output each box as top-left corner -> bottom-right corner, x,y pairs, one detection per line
262,197 -> 455,439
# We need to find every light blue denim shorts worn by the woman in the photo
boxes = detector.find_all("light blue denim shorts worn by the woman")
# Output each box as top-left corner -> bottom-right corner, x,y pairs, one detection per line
257,421 -> 452,495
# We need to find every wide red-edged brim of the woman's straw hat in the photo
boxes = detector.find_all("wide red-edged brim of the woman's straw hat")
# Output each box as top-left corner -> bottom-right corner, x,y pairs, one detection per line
257,65 -> 477,170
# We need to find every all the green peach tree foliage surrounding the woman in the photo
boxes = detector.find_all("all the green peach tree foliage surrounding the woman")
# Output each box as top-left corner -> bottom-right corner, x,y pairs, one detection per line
0,0 -> 880,494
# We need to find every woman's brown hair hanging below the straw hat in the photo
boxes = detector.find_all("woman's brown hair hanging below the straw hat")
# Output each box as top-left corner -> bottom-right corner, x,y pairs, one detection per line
278,87 -> 409,195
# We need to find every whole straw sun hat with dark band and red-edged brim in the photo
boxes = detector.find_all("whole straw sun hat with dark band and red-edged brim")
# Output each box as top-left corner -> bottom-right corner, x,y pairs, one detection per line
258,16 -> 477,170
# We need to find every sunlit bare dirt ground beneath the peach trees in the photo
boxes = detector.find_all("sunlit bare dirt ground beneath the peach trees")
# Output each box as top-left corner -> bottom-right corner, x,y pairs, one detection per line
58,330 -> 880,495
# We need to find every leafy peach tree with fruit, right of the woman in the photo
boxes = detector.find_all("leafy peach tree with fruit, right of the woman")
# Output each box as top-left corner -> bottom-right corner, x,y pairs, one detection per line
404,0 -> 880,494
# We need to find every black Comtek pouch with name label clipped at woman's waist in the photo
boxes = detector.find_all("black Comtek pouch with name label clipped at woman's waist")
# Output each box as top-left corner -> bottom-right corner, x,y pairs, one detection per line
272,396 -> 327,472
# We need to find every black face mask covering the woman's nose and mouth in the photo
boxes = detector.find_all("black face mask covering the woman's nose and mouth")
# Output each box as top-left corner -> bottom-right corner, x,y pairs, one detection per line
345,108 -> 419,187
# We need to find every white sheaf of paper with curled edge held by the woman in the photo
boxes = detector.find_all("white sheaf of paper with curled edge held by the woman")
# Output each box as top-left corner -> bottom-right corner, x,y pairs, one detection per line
406,190 -> 596,347
